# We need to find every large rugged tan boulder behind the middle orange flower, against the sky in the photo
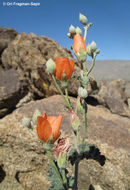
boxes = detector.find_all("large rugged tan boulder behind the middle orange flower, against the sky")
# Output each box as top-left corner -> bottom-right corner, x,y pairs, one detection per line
2,33 -> 94,99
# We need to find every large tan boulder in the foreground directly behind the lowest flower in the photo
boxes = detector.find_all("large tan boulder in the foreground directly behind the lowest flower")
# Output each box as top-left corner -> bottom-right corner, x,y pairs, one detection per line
0,95 -> 130,190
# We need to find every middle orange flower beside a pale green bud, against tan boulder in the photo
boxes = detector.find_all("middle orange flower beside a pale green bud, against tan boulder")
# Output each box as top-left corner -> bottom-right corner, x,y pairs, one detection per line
54,57 -> 74,80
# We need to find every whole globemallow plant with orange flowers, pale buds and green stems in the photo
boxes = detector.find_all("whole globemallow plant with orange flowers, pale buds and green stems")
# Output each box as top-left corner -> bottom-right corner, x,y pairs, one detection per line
23,14 -> 106,190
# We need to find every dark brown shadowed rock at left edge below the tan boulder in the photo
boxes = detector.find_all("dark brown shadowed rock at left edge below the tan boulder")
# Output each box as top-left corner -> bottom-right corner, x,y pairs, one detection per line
0,69 -> 28,118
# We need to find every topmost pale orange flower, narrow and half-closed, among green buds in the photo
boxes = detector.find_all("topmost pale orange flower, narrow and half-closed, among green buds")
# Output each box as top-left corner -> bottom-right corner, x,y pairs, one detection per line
73,34 -> 87,54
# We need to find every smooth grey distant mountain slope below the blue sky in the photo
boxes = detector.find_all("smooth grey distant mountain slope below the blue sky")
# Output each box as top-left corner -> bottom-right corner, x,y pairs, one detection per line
86,60 -> 130,82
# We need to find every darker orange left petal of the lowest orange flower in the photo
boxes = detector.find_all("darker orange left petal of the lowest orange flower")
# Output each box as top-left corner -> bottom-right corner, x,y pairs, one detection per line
36,114 -> 52,142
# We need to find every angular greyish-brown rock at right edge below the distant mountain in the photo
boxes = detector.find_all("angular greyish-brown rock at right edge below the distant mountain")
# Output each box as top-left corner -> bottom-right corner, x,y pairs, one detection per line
94,79 -> 130,117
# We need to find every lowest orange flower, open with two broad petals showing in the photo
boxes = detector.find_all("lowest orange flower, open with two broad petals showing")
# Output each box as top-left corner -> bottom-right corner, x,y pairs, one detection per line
36,113 -> 62,142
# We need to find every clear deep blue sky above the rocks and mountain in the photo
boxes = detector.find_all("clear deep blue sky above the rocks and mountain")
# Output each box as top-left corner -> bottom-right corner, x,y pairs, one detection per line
0,0 -> 130,60
